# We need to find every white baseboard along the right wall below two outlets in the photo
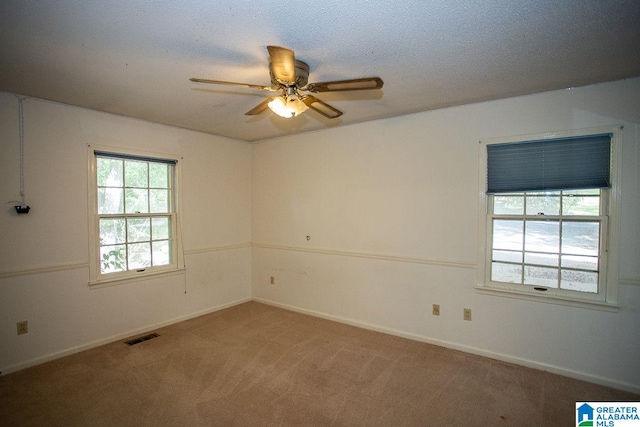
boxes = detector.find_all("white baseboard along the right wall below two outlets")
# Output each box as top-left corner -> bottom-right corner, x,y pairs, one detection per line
253,298 -> 640,394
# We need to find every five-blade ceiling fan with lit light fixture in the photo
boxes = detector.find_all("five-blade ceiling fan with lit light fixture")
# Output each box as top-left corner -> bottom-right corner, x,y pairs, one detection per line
189,46 -> 384,119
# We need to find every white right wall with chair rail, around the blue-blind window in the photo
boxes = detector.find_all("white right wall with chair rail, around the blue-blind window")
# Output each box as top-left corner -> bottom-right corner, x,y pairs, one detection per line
252,79 -> 640,392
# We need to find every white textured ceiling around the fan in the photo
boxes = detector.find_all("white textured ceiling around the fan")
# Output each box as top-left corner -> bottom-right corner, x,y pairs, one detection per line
0,0 -> 640,141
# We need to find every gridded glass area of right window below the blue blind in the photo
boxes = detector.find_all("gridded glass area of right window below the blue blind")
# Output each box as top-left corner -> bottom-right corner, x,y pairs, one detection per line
489,189 -> 607,294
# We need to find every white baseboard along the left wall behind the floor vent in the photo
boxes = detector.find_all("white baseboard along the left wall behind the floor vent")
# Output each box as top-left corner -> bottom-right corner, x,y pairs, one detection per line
0,298 -> 251,375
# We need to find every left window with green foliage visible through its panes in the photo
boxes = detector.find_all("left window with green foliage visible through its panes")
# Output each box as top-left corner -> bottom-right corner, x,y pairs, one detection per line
89,148 -> 182,284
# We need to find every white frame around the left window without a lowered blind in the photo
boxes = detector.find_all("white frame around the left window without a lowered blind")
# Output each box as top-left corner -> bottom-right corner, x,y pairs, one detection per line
87,144 -> 185,288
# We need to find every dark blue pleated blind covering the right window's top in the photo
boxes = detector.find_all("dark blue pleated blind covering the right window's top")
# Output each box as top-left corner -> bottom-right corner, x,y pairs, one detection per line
487,134 -> 611,194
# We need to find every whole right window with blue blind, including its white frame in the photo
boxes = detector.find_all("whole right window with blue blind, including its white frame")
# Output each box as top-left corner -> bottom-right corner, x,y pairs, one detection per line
477,129 -> 619,307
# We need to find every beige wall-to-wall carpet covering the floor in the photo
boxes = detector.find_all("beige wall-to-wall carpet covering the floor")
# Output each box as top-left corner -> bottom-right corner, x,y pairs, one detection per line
0,302 -> 640,426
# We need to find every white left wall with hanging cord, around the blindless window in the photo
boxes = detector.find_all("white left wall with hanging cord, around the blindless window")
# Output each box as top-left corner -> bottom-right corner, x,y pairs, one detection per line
0,93 -> 251,373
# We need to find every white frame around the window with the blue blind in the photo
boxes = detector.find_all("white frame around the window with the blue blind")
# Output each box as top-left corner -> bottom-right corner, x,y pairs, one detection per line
475,126 -> 622,311
